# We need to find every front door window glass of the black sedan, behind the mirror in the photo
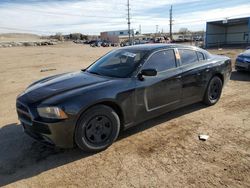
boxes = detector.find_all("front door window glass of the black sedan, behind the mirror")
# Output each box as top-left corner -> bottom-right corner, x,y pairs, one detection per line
143,50 -> 176,72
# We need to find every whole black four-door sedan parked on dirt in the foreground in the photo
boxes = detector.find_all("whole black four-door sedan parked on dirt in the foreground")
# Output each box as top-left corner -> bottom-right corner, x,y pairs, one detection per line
16,44 -> 231,151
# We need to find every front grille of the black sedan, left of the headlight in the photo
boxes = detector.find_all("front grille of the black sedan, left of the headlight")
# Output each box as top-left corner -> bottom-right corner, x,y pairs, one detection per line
16,101 -> 32,125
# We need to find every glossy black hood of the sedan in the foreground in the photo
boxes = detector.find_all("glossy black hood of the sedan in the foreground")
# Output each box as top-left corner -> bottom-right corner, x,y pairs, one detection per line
20,71 -> 111,102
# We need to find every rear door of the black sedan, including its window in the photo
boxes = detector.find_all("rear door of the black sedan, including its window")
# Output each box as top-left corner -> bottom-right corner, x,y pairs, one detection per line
178,49 -> 206,103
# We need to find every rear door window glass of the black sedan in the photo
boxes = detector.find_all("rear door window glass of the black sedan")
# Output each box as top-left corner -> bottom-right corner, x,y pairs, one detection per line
178,49 -> 198,65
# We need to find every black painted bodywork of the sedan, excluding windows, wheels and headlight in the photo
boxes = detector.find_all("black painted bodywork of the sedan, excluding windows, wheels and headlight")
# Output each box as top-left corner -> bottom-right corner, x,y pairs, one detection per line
17,44 -> 231,148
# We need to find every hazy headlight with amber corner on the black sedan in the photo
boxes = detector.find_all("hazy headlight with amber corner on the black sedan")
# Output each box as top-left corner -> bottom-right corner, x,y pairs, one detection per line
37,107 -> 68,119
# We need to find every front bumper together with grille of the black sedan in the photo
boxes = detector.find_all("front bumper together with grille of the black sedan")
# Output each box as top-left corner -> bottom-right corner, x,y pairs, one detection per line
17,102 -> 75,148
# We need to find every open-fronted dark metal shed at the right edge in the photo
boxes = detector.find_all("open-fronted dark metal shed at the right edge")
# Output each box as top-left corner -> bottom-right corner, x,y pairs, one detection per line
205,17 -> 250,48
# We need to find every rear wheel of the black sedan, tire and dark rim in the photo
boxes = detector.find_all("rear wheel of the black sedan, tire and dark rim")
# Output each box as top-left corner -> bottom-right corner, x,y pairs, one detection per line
203,76 -> 223,106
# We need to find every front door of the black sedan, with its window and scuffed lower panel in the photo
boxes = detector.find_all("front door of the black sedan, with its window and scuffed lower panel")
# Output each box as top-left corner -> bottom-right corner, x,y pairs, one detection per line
136,49 -> 182,120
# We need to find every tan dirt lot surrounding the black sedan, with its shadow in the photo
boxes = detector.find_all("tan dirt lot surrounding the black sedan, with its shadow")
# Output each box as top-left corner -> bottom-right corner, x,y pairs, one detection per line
0,43 -> 250,187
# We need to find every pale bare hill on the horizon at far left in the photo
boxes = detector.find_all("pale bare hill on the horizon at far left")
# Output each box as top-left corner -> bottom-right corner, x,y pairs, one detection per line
0,33 -> 42,42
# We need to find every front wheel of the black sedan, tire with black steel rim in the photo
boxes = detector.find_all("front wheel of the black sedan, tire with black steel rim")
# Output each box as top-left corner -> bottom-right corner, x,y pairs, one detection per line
75,105 -> 120,152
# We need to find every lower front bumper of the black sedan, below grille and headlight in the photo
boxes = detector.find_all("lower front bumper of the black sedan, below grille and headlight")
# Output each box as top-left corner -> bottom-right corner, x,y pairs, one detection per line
20,120 -> 75,148
